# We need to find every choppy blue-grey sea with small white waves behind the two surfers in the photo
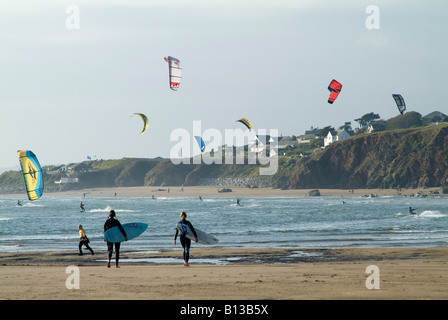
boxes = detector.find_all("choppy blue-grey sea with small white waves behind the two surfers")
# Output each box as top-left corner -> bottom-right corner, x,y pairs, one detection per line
0,195 -> 448,252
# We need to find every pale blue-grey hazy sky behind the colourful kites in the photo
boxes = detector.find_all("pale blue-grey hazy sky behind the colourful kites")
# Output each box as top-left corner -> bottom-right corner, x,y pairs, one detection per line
0,0 -> 448,170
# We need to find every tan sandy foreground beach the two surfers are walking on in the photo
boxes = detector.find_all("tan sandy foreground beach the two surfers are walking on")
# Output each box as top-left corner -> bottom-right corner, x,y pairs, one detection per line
0,247 -> 448,300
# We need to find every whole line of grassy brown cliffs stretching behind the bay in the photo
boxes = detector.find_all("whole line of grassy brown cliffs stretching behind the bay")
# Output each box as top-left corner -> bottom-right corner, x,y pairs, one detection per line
0,124 -> 448,193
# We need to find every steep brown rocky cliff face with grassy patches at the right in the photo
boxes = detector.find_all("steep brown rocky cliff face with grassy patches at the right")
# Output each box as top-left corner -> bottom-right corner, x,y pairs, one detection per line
284,125 -> 448,188
